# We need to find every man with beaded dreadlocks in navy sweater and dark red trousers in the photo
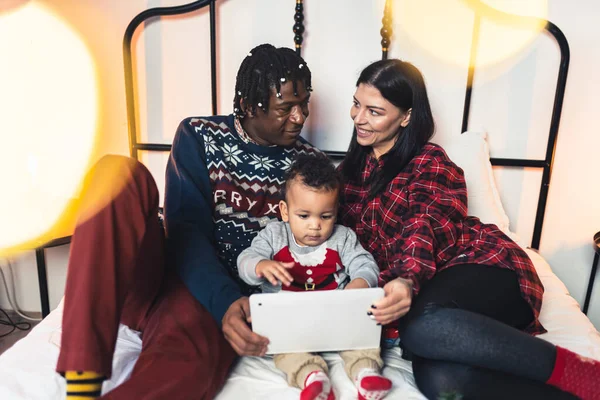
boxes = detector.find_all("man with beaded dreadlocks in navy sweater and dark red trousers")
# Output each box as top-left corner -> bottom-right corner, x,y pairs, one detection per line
56,44 -> 317,400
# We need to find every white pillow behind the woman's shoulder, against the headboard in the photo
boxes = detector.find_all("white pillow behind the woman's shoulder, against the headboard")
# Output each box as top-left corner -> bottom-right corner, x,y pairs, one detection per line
435,131 -> 513,236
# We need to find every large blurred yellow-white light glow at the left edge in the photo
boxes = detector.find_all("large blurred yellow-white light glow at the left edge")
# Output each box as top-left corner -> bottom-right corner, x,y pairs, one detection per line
0,3 -> 97,255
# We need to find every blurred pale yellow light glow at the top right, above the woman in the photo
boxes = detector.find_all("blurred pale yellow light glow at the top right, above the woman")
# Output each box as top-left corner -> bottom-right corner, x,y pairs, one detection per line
392,0 -> 548,67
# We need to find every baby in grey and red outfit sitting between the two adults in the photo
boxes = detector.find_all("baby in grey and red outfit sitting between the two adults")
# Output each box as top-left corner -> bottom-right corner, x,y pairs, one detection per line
237,155 -> 392,400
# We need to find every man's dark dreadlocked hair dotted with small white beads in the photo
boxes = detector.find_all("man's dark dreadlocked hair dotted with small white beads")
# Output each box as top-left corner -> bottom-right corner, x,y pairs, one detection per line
233,43 -> 312,118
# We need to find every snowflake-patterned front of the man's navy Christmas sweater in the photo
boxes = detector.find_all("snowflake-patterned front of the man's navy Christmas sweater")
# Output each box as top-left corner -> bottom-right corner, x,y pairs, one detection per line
185,115 -> 319,294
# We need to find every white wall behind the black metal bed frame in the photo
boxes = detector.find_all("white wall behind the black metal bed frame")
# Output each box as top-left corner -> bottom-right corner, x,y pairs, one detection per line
0,0 -> 600,327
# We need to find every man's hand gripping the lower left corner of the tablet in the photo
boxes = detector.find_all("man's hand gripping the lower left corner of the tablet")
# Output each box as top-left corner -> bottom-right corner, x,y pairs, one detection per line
222,297 -> 269,357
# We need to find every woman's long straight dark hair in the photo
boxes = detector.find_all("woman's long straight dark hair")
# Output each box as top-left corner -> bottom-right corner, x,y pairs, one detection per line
342,59 -> 435,198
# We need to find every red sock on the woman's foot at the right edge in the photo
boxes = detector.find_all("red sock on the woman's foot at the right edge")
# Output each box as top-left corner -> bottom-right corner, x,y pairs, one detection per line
546,346 -> 600,400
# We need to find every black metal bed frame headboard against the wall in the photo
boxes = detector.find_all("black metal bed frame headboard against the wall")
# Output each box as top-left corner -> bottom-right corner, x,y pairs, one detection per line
123,0 -> 570,250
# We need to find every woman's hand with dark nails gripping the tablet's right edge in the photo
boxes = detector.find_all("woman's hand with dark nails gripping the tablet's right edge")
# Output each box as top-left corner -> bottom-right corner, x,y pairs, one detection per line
369,278 -> 412,325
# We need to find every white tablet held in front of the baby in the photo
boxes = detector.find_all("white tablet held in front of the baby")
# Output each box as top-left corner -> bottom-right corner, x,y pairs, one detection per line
250,288 -> 384,354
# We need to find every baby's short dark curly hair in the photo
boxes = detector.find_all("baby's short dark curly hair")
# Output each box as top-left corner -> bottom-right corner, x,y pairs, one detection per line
281,153 -> 342,200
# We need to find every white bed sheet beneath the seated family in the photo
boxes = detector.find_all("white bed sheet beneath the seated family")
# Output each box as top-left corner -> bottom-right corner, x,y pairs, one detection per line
0,250 -> 600,400
